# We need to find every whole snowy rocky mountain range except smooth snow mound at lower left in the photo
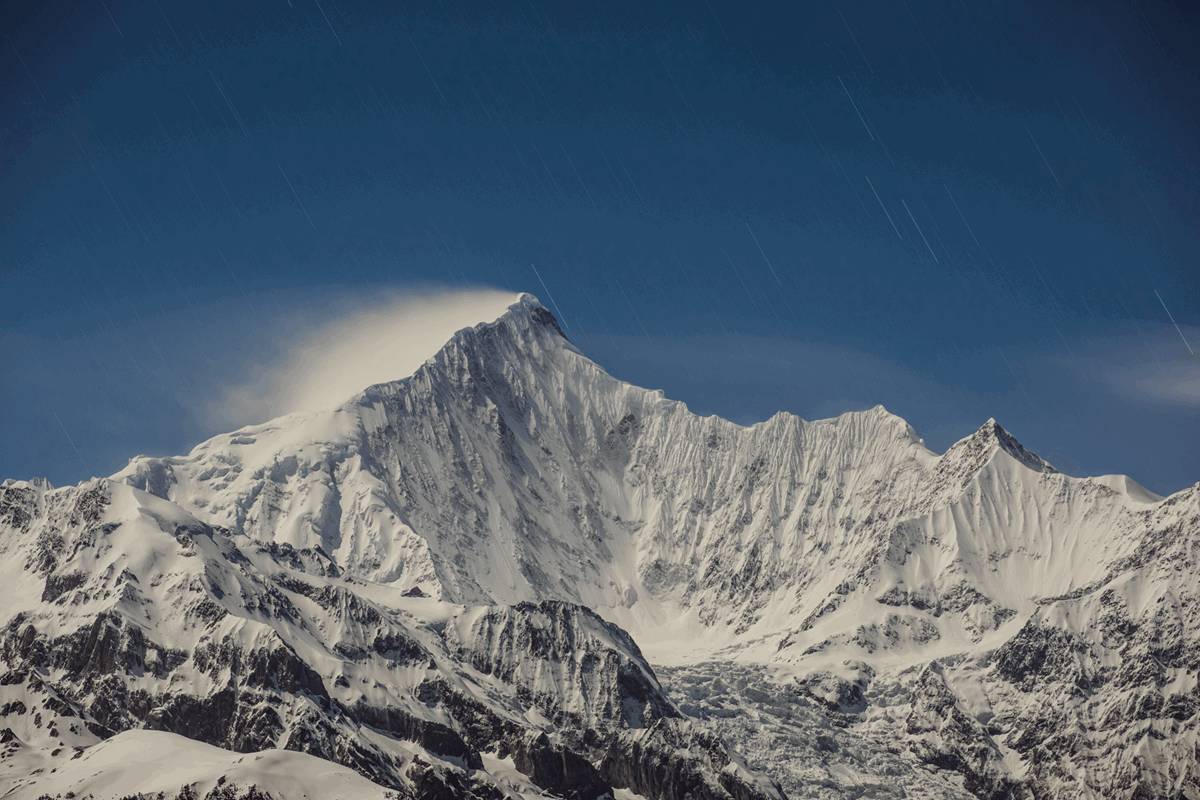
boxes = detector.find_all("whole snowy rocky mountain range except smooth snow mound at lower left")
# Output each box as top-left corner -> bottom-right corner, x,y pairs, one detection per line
0,295 -> 1200,799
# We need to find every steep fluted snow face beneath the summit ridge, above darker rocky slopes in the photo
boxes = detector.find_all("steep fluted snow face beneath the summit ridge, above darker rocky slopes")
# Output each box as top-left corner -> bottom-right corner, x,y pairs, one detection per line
116,295 -> 1171,660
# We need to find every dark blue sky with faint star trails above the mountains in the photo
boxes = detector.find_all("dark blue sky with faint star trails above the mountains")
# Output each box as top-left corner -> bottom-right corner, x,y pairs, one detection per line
0,0 -> 1200,492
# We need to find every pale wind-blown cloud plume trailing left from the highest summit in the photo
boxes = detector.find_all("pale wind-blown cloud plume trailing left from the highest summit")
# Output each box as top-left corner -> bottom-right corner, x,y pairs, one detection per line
210,289 -> 516,425
